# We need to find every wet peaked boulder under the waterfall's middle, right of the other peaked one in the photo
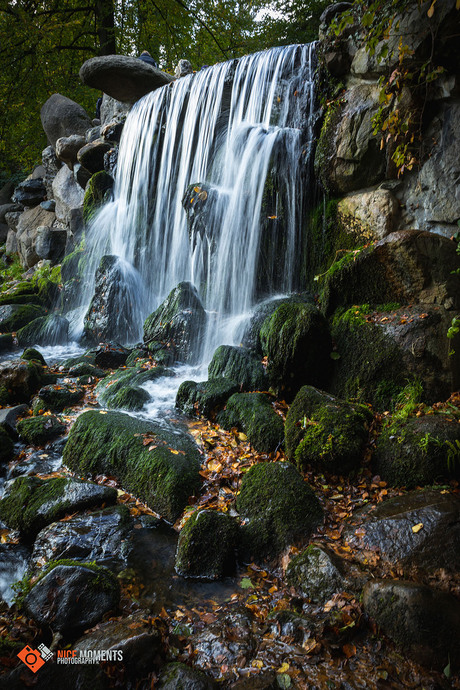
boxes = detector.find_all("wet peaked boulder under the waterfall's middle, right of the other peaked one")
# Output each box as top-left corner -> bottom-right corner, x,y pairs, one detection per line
144,282 -> 207,362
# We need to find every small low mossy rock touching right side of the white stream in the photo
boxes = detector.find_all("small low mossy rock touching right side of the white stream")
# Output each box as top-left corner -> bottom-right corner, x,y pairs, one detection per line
176,378 -> 238,418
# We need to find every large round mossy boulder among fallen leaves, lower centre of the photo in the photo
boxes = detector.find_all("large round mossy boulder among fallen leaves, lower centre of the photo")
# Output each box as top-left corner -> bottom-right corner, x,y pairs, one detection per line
236,462 -> 323,560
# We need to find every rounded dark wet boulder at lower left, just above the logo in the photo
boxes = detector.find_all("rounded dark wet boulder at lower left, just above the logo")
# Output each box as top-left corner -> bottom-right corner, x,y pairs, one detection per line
24,561 -> 120,638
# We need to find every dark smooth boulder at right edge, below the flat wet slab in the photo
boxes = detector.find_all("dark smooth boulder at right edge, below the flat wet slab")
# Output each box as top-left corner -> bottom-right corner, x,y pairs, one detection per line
363,580 -> 460,670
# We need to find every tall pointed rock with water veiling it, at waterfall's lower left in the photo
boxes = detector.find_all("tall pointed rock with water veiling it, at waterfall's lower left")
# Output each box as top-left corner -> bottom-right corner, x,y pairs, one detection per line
84,255 -> 143,342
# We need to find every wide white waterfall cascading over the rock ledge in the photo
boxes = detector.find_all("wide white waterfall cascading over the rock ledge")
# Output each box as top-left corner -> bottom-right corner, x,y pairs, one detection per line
76,44 -> 315,358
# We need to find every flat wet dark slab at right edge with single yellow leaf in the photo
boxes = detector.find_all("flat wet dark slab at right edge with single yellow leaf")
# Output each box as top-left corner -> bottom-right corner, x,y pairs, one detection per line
345,490 -> 460,572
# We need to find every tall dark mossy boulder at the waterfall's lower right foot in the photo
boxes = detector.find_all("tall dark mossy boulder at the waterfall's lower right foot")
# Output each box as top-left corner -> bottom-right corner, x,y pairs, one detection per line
260,303 -> 332,400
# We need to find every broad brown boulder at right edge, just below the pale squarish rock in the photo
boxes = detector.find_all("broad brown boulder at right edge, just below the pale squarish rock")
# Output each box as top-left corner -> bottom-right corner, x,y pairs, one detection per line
321,230 -> 460,315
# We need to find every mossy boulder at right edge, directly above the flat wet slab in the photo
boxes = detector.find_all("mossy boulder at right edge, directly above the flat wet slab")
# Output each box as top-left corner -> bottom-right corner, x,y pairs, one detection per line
372,415 -> 460,489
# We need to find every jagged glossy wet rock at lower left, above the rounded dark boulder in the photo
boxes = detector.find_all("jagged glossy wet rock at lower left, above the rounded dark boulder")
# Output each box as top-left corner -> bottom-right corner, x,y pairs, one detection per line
29,505 -> 133,571
